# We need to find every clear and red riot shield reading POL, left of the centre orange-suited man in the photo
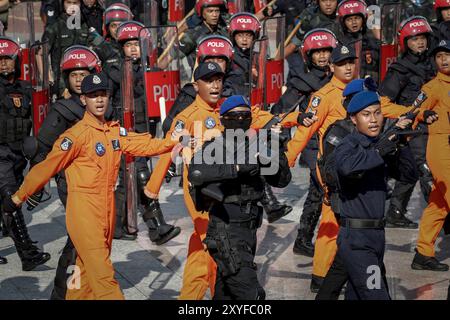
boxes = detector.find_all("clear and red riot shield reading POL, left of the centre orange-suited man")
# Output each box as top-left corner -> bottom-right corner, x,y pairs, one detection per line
140,26 -> 181,122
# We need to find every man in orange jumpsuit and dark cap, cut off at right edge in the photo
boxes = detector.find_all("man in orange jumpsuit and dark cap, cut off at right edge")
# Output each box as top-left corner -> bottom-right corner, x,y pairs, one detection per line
411,40 -> 450,271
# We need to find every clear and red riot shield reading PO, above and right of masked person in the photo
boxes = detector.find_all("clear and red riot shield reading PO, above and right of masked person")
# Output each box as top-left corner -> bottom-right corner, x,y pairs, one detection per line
251,16 -> 285,109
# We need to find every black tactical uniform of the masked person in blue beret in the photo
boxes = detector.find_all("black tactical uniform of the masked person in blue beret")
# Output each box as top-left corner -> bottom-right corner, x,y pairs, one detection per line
189,127 -> 291,300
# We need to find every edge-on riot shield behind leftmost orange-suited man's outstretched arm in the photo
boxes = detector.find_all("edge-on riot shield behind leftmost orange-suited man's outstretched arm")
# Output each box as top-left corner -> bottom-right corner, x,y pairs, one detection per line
120,59 -> 138,233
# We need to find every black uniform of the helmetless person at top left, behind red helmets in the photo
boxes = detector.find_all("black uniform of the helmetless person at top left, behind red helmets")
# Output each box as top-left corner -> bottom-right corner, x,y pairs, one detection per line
42,13 -> 91,97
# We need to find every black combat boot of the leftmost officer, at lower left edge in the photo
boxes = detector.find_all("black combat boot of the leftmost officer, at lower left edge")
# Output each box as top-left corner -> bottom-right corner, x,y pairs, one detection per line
4,210 -> 50,271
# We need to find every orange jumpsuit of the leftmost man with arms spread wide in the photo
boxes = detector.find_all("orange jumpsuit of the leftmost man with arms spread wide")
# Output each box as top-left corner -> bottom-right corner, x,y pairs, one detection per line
15,112 -> 175,300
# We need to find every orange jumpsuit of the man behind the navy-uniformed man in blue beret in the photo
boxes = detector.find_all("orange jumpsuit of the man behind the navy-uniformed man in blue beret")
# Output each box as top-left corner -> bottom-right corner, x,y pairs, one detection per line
286,77 -> 416,277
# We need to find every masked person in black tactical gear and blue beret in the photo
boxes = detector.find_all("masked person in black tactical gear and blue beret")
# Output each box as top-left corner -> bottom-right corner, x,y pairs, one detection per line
188,96 -> 291,300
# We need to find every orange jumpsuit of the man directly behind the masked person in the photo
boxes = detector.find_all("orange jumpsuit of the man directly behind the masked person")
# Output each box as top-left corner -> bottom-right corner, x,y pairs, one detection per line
146,95 -> 299,300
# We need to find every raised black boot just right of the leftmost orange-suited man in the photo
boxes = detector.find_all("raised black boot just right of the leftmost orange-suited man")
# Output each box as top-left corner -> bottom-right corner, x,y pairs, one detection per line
142,199 -> 181,245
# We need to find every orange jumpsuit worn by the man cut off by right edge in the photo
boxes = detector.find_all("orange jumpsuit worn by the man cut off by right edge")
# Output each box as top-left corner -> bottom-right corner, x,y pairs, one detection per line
417,72 -> 450,257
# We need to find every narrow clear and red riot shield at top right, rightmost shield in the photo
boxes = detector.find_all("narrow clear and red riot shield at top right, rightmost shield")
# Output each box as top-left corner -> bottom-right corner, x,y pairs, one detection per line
380,3 -> 402,82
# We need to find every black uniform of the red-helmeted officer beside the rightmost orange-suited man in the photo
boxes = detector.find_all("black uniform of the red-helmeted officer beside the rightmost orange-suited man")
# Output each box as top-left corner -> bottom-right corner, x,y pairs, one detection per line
380,50 -> 434,228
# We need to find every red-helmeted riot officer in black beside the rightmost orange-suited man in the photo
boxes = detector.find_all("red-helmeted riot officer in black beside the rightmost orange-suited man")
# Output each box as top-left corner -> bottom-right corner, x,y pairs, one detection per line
380,16 -> 434,229
